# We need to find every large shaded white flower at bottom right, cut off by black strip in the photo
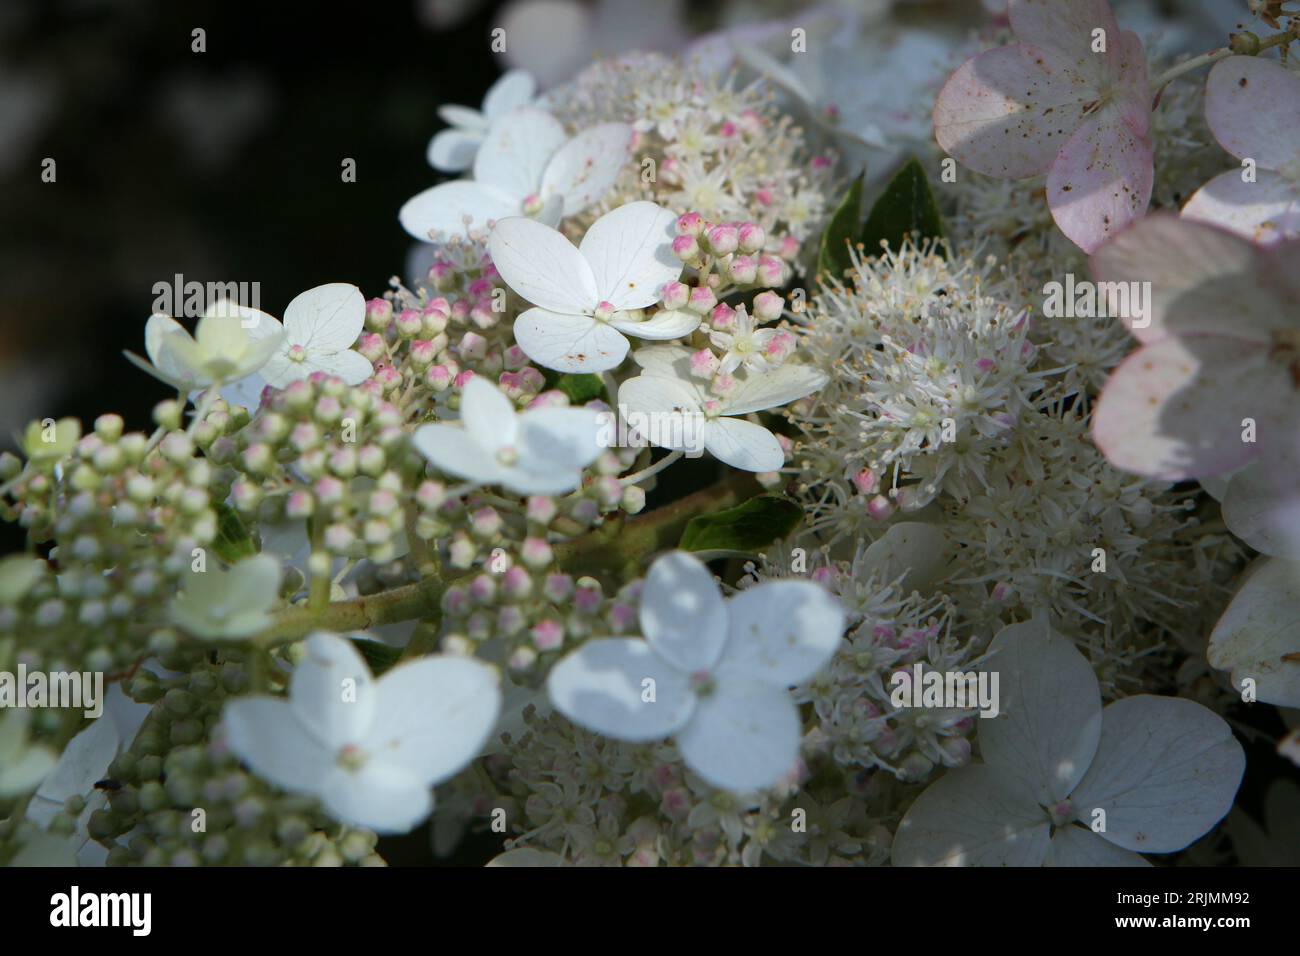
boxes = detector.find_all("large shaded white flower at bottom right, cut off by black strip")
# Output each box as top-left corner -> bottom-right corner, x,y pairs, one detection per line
893,620 -> 1245,866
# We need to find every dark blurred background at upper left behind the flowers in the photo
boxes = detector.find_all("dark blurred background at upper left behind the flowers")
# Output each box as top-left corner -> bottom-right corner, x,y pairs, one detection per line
0,0 -> 527,445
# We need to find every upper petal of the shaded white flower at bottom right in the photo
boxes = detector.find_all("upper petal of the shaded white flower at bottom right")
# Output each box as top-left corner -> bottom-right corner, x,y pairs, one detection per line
979,622 -> 1101,806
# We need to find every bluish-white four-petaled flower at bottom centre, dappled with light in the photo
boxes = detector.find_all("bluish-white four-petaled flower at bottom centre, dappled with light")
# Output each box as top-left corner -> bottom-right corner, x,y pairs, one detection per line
547,551 -> 845,792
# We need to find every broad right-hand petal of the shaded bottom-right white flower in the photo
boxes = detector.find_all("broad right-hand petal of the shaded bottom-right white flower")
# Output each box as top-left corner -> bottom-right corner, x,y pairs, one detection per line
1070,695 -> 1245,853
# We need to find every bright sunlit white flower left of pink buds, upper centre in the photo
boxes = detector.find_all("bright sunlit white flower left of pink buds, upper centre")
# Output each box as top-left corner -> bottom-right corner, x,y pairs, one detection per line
488,202 -> 699,372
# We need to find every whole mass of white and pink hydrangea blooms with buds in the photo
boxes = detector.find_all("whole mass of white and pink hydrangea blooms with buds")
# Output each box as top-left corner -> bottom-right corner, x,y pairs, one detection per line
0,0 -> 1300,866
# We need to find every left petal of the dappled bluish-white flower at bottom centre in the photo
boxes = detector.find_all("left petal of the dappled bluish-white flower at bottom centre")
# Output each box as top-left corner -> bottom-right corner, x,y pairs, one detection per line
546,637 -> 694,740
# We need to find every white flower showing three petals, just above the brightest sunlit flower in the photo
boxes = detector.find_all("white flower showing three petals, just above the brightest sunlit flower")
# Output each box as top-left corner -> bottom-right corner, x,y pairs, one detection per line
398,107 -> 633,242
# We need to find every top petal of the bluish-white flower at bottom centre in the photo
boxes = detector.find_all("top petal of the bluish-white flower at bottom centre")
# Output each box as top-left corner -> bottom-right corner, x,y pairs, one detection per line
641,551 -> 727,674
